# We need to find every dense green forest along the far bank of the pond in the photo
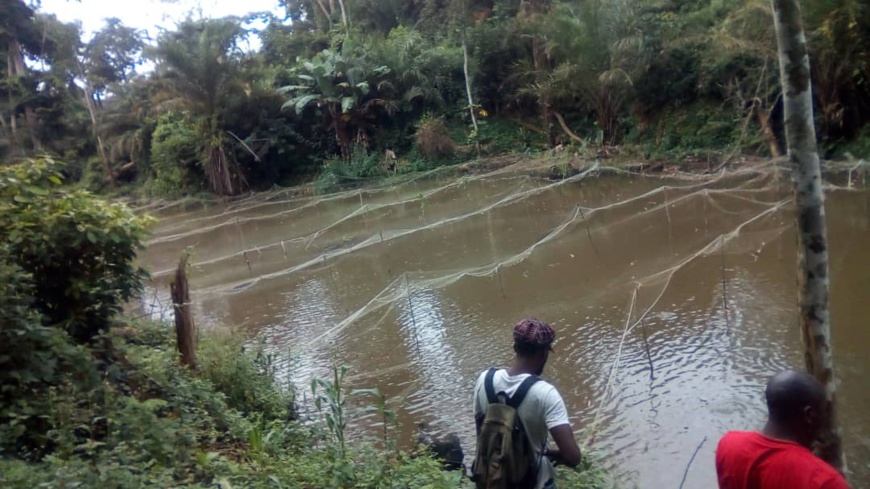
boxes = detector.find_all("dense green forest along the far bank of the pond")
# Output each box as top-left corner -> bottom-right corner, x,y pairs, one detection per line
0,0 -> 870,196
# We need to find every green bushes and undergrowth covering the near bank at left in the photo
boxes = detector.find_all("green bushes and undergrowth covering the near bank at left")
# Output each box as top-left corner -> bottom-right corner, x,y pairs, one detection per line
0,158 -> 606,489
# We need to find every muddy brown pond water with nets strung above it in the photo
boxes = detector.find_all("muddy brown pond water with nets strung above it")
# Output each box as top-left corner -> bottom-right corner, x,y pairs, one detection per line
141,163 -> 870,488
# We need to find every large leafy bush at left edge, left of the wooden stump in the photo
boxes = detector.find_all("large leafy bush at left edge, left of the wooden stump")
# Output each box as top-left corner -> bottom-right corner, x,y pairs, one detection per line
0,158 -> 148,343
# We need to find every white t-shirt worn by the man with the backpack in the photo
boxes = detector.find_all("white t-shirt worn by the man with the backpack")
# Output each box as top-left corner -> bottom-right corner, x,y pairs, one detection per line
474,369 -> 571,489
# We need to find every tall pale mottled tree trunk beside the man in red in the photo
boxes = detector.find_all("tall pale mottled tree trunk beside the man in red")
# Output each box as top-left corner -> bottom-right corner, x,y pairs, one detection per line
772,0 -> 844,470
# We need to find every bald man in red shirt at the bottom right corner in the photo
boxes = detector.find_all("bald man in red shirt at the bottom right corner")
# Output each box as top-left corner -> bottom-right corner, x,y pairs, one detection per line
716,370 -> 849,489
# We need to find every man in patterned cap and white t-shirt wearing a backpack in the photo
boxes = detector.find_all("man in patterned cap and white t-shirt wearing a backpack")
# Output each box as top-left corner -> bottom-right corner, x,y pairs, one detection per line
472,319 -> 580,489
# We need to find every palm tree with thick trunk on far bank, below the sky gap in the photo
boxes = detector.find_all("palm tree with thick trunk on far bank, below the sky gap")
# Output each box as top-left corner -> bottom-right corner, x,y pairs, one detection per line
153,18 -> 247,195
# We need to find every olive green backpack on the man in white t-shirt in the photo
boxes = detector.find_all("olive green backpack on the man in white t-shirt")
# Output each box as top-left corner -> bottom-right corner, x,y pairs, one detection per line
472,368 -> 540,489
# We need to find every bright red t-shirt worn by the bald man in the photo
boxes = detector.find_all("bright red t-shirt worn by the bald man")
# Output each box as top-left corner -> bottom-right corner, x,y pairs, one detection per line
716,431 -> 849,489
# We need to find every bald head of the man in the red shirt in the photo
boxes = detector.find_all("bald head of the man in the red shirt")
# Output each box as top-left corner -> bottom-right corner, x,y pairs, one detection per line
764,370 -> 827,447
